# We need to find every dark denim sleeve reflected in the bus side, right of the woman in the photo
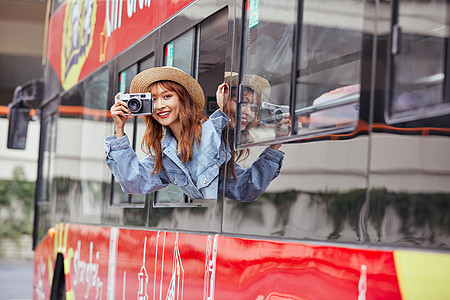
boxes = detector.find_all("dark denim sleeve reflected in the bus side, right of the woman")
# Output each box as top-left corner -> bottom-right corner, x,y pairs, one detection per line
219,147 -> 284,202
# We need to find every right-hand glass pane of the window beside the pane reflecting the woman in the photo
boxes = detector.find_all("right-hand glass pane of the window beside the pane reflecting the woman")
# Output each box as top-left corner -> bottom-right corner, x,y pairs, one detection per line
295,0 -> 364,135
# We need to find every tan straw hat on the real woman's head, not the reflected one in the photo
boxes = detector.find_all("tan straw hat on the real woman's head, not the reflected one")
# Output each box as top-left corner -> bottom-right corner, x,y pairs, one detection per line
130,67 -> 205,109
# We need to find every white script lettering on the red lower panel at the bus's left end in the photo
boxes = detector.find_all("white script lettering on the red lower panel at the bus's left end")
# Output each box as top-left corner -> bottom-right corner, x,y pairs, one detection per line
73,240 -> 103,299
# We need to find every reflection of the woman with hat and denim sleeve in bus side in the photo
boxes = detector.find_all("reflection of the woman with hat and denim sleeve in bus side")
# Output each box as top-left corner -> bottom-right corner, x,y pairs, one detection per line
216,74 -> 284,201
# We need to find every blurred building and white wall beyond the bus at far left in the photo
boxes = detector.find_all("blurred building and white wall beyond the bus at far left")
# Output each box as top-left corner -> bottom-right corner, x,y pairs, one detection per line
0,0 -> 47,258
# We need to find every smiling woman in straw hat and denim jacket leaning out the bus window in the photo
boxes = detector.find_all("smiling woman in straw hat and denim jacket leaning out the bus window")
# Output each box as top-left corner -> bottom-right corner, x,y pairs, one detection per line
105,67 -> 228,199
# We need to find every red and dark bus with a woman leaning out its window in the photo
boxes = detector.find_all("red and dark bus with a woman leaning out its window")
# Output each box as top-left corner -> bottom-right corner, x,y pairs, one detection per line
10,0 -> 450,300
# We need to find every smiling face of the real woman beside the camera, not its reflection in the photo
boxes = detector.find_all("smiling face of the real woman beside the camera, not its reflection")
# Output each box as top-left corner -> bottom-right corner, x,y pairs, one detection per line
149,83 -> 181,139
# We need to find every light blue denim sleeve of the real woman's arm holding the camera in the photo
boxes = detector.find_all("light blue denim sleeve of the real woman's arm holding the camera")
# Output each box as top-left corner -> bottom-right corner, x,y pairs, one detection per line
105,136 -> 168,195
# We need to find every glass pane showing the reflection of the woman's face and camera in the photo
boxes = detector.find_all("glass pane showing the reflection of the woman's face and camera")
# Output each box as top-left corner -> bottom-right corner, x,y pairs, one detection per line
237,0 -> 297,145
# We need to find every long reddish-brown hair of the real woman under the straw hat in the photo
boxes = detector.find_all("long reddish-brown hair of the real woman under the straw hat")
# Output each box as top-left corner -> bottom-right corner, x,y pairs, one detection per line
141,80 -> 207,174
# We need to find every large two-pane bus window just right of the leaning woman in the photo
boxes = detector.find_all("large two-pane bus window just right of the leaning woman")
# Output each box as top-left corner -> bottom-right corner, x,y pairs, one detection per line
238,0 -> 364,146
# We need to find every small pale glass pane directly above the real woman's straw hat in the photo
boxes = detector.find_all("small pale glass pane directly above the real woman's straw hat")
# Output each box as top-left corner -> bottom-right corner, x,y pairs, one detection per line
164,28 -> 195,76
